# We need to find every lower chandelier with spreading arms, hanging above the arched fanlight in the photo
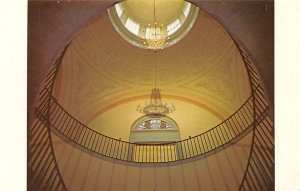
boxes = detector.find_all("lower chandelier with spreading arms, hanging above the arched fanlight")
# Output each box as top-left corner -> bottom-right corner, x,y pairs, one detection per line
136,51 -> 175,115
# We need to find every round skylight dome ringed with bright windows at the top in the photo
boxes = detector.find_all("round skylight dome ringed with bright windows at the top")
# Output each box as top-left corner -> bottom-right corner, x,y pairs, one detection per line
108,0 -> 198,50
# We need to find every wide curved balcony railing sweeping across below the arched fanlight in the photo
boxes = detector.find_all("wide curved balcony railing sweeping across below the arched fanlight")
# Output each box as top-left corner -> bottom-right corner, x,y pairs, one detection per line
37,86 -> 266,163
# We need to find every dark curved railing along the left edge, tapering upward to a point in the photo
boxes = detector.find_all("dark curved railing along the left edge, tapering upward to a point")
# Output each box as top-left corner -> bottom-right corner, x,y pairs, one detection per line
27,47 -> 67,191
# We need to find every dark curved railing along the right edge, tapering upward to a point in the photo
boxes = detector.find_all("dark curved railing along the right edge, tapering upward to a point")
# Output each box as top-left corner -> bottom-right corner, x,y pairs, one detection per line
232,37 -> 275,191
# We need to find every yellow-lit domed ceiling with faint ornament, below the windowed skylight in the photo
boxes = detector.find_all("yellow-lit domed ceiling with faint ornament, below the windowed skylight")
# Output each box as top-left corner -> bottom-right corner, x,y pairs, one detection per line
54,1 -> 250,140
